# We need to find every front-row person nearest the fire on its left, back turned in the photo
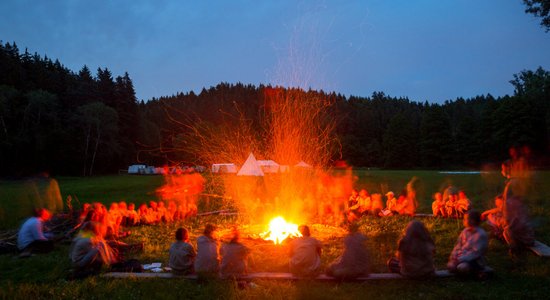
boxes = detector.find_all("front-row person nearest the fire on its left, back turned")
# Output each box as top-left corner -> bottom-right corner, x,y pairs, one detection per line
220,228 -> 250,278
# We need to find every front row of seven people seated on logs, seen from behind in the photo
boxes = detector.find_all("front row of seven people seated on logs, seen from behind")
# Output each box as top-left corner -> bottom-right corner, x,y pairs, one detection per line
161,211 -> 488,279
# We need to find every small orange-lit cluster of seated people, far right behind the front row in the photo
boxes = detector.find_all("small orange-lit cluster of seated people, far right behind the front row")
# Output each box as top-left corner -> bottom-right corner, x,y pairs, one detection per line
432,187 -> 472,218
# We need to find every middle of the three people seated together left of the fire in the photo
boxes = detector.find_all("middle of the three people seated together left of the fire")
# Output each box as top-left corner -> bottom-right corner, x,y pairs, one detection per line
195,224 -> 220,277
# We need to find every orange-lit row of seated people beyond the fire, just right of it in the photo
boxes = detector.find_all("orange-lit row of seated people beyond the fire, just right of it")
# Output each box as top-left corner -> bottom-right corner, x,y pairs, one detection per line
346,189 -> 417,222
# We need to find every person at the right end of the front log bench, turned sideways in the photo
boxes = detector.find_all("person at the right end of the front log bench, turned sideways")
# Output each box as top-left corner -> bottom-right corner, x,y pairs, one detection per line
447,211 -> 488,275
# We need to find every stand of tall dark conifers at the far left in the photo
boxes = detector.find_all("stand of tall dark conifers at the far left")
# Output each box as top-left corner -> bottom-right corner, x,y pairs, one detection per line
0,43 -> 140,176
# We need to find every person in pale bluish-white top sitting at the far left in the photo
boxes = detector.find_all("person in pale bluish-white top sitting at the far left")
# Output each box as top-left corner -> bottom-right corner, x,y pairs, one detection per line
17,208 -> 54,257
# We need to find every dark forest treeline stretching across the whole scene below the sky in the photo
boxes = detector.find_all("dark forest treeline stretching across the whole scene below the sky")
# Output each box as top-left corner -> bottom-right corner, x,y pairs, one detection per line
0,43 -> 550,175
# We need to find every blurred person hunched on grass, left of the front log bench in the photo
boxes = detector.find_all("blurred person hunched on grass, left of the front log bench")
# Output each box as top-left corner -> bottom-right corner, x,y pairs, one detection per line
69,221 -> 117,279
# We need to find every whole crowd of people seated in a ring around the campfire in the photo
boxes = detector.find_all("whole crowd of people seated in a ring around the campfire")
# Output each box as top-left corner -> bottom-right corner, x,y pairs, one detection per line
12,146 -> 534,279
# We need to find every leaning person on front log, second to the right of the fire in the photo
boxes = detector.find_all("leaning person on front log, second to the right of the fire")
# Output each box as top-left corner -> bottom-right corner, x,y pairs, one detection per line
326,223 -> 370,279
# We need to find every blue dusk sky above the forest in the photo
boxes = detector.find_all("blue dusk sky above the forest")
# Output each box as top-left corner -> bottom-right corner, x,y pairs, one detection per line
0,0 -> 550,102
